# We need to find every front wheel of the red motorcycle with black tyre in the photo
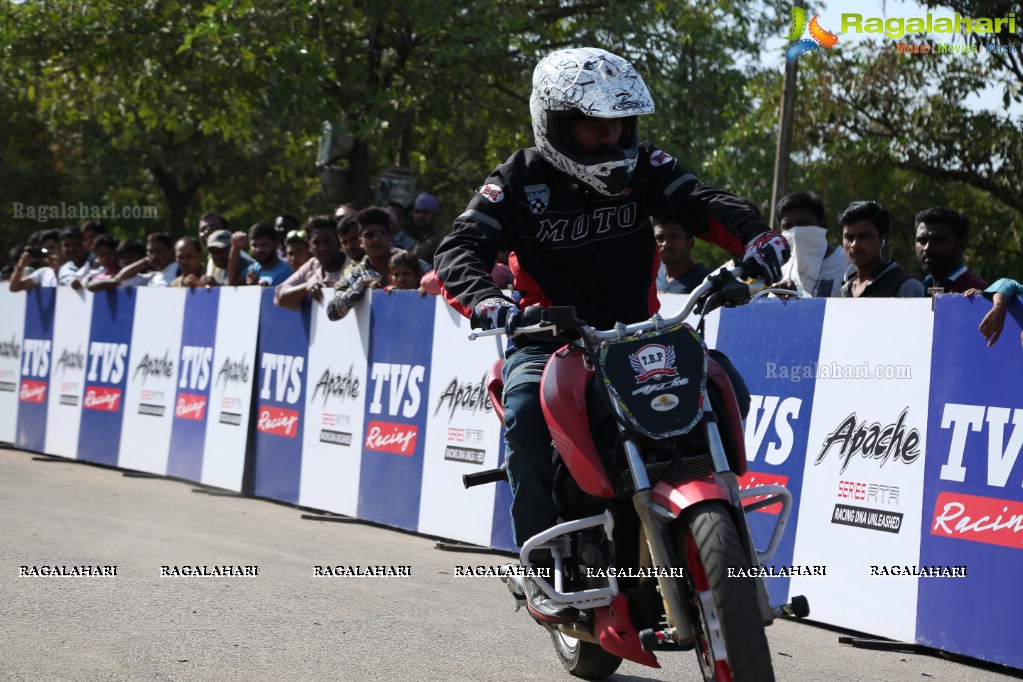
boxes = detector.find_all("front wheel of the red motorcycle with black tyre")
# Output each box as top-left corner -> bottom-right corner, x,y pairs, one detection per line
675,502 -> 774,682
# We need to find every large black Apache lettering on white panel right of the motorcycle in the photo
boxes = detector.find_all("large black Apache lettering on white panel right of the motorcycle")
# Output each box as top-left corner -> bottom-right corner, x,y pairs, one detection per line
813,407 -> 920,473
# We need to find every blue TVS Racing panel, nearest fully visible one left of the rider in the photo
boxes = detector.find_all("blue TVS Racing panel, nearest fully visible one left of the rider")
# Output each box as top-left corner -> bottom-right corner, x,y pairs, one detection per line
359,291 -> 437,531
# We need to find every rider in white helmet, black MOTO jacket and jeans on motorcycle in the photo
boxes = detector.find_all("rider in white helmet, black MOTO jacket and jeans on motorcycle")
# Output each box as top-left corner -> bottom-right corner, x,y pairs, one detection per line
435,47 -> 789,622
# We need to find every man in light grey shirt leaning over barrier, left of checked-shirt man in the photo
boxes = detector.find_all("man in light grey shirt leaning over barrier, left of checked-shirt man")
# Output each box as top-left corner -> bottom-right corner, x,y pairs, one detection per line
273,216 -> 354,310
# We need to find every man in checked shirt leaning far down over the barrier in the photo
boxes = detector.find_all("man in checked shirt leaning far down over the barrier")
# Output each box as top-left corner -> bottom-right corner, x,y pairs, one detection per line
326,207 -> 431,320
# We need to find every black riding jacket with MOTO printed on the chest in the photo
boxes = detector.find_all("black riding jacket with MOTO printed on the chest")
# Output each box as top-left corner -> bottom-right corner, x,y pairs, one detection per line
435,143 -> 767,328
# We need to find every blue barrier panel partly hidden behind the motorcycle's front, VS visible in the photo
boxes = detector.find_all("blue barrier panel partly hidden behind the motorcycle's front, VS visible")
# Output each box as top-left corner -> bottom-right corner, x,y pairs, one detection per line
717,299 -> 826,602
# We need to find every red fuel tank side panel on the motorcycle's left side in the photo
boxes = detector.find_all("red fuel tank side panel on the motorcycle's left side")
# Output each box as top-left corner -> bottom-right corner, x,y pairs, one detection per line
540,348 -> 615,497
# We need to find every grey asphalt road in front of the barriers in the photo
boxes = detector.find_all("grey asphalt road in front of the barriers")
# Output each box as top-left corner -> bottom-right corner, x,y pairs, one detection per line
0,450 -> 1023,682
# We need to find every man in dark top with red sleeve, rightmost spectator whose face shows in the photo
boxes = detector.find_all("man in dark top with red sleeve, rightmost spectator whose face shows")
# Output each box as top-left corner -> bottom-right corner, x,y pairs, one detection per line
914,207 -> 987,293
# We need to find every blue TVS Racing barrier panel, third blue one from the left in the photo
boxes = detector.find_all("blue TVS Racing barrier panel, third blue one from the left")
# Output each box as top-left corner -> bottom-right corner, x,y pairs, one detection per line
167,287 -> 220,482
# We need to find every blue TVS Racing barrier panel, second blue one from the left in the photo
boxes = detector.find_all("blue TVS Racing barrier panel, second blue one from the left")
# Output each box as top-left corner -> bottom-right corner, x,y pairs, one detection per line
78,288 -> 137,466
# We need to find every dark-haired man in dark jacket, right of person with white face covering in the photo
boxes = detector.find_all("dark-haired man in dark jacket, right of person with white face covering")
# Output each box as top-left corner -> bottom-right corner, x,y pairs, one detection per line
838,201 -> 924,299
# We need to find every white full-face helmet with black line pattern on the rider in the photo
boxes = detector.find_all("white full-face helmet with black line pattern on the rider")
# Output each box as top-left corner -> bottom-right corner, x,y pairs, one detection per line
529,47 -> 654,196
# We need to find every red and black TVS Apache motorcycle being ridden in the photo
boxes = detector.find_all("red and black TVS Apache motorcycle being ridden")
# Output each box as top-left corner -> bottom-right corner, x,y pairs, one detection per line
463,268 -> 808,681
